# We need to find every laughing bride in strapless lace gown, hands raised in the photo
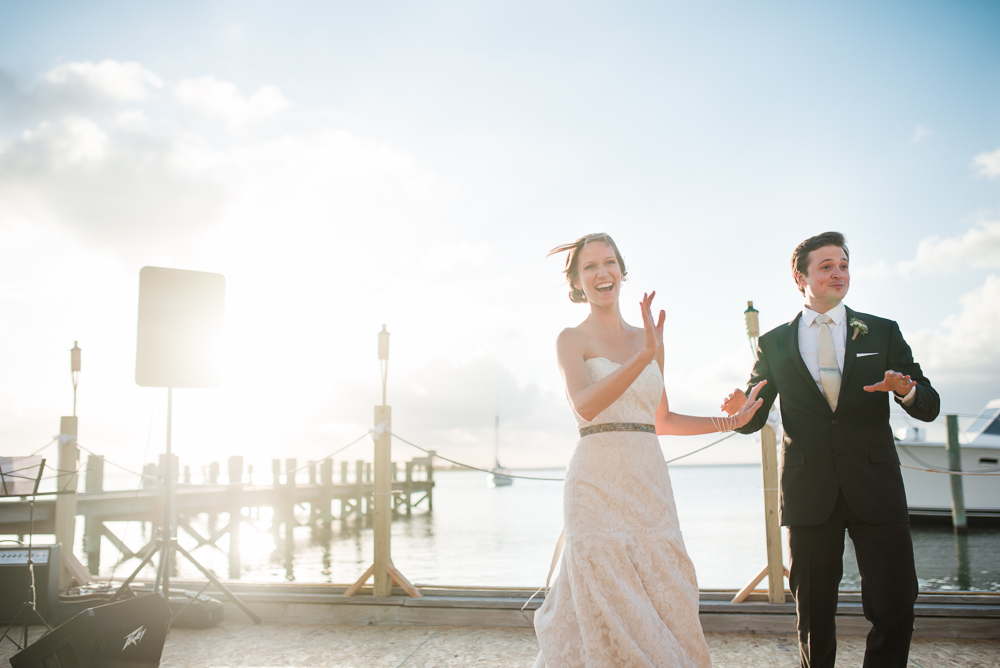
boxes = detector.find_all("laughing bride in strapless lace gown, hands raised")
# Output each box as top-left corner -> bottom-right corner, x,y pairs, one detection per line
535,234 -> 763,668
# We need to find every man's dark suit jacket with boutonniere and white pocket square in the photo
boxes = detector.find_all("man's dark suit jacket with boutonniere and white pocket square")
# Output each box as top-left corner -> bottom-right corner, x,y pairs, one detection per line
737,309 -> 941,526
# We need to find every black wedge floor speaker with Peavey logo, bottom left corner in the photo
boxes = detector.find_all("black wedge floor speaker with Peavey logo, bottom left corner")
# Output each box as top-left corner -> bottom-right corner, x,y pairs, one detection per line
10,594 -> 170,668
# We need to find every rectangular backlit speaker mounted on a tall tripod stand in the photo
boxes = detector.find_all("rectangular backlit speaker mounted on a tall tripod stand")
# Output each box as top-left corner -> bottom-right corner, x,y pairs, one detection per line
135,267 -> 226,387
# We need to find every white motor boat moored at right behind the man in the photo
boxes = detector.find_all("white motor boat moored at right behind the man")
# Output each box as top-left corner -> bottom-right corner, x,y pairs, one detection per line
896,399 -> 1000,520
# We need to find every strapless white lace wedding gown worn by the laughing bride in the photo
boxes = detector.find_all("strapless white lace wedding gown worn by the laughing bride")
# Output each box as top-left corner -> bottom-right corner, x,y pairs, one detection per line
535,357 -> 712,668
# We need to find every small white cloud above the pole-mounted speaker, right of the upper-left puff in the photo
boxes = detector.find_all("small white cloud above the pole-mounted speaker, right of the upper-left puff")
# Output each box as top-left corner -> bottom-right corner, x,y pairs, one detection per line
174,76 -> 288,129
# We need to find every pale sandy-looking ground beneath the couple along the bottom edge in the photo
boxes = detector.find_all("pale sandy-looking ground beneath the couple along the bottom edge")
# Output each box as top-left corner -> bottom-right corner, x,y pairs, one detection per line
0,620 -> 1000,668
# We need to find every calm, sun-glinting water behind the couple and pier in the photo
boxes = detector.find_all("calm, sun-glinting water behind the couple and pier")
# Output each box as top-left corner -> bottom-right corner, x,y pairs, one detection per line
88,465 -> 1000,591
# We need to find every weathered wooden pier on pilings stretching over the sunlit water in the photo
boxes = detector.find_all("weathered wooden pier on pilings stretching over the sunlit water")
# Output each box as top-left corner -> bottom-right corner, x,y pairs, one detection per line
0,454 -> 434,579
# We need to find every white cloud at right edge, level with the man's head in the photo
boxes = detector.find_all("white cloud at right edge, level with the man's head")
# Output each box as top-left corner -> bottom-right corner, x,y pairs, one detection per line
899,221 -> 1000,275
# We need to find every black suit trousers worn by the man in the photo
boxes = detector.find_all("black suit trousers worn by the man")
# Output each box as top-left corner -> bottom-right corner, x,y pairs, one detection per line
788,491 -> 917,668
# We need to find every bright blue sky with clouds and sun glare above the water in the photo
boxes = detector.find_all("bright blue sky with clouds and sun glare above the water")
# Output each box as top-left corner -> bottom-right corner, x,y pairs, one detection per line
0,0 -> 1000,471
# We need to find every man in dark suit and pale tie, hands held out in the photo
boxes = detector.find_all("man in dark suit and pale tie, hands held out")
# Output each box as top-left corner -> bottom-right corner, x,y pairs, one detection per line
724,232 -> 940,668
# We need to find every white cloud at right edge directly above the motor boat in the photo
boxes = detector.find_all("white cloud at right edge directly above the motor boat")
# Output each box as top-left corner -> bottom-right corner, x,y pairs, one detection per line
907,275 -> 1000,386
